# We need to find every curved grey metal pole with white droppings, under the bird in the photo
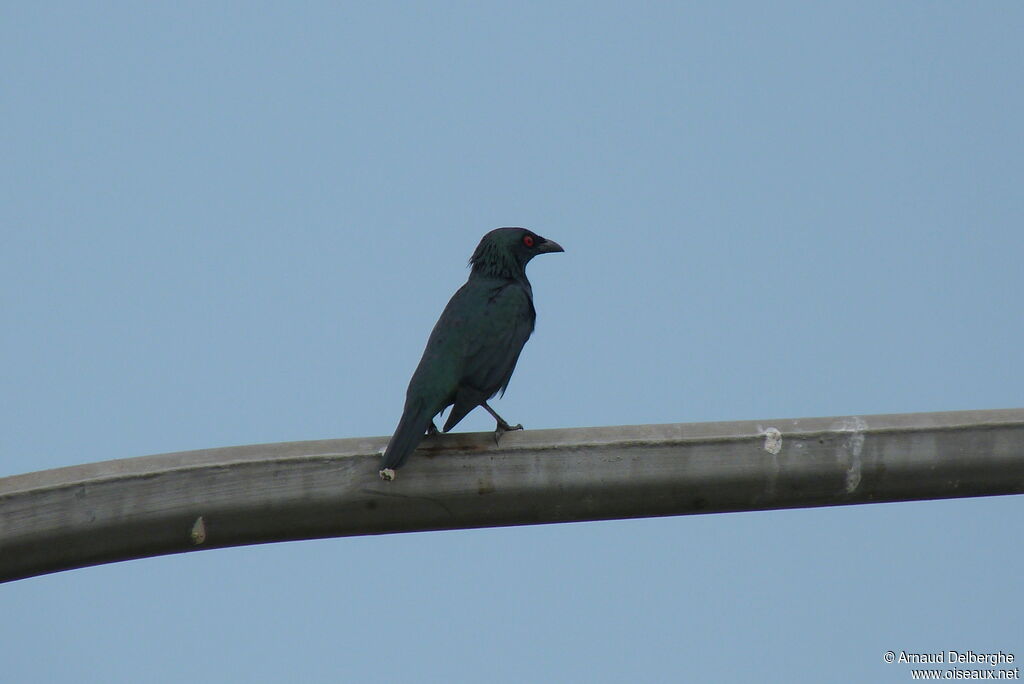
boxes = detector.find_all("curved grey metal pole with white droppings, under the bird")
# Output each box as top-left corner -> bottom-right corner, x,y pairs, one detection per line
0,409 -> 1024,582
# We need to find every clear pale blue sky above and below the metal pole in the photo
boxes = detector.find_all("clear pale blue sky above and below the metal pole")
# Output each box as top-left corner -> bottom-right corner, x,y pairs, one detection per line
0,2 -> 1024,683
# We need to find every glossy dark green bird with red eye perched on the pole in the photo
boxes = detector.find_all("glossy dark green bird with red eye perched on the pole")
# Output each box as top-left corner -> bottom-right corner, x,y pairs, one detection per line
380,228 -> 564,480
